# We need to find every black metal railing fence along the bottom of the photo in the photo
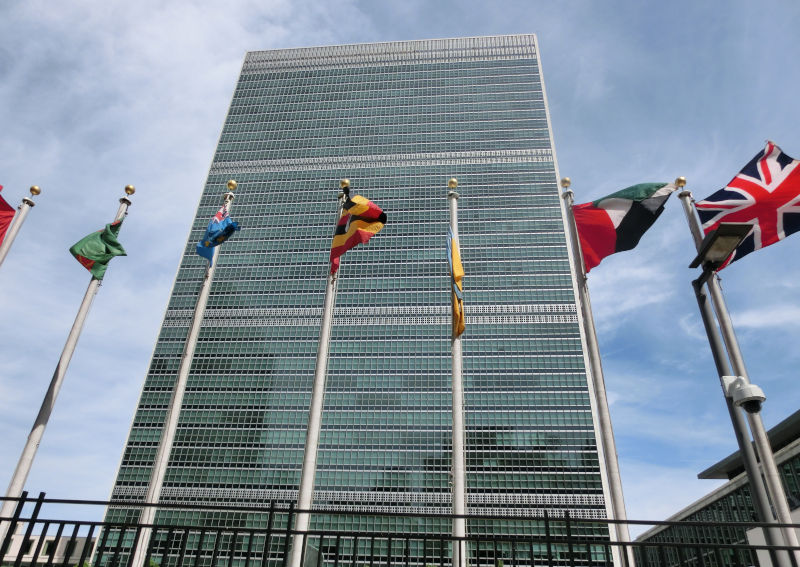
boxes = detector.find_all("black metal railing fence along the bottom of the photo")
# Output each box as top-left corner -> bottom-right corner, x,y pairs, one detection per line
0,493 -> 800,567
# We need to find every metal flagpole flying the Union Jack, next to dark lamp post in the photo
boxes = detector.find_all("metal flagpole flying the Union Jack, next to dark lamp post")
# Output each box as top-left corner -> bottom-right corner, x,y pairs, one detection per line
678,189 -> 800,564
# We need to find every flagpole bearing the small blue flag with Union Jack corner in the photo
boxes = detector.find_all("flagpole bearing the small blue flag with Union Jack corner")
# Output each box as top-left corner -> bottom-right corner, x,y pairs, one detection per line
131,179 -> 237,567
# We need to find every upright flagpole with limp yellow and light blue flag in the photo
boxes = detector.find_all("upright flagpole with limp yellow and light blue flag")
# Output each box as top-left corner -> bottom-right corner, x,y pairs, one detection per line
447,178 -> 467,567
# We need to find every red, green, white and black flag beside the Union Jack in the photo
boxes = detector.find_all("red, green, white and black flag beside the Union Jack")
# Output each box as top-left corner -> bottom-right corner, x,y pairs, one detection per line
572,183 -> 677,273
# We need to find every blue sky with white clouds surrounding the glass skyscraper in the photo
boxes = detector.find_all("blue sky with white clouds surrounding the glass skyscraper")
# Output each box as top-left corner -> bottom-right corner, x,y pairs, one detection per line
0,0 -> 800,532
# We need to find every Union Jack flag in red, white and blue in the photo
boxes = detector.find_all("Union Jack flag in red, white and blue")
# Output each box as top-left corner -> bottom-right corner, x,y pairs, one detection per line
695,142 -> 800,269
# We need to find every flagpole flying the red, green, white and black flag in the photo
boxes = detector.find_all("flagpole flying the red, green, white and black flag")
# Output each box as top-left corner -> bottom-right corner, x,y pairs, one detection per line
561,177 -> 635,567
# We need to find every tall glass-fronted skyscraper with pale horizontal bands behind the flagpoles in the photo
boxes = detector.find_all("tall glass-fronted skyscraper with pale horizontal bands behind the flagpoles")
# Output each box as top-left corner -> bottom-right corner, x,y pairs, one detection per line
112,35 -> 608,529
